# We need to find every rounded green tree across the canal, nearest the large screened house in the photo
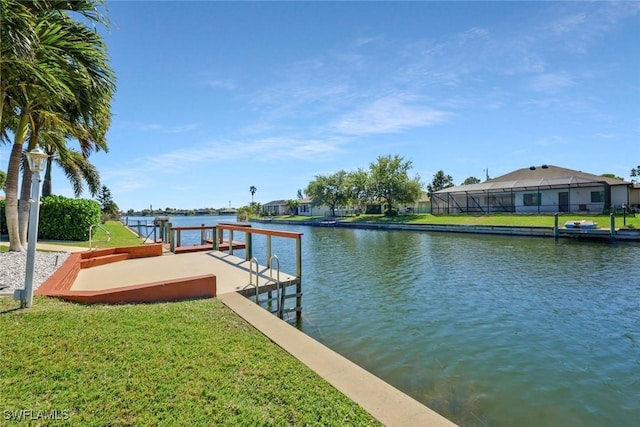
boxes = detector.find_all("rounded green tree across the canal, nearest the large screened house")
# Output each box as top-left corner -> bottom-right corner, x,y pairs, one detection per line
369,155 -> 422,215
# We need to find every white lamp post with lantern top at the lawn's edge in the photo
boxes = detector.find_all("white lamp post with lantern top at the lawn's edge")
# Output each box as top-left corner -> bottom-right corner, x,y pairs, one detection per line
14,147 -> 49,308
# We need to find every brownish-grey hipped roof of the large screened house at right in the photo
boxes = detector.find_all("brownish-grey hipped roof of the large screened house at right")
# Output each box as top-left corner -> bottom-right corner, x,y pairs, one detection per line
435,165 -> 631,194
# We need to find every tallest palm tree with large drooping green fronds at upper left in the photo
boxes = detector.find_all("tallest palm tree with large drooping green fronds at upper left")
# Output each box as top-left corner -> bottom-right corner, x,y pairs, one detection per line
0,0 -> 115,251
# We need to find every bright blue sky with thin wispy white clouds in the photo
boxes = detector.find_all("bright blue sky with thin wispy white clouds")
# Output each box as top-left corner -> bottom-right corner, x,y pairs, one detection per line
0,1 -> 640,211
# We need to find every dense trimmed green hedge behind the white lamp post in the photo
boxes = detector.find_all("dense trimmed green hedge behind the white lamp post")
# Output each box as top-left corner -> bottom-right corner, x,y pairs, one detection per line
38,196 -> 101,241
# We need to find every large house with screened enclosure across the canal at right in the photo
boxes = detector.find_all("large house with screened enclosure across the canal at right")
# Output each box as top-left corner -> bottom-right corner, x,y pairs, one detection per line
431,165 -> 632,215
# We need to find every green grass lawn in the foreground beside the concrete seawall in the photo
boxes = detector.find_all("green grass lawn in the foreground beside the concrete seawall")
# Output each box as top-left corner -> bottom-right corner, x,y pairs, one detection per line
0,296 -> 378,425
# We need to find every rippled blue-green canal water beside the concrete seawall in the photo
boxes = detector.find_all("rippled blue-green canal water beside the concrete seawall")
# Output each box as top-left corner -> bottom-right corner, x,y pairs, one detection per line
126,218 -> 640,427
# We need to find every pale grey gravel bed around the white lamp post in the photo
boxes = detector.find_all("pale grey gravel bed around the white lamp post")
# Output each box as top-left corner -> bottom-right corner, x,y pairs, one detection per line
0,252 -> 69,293
